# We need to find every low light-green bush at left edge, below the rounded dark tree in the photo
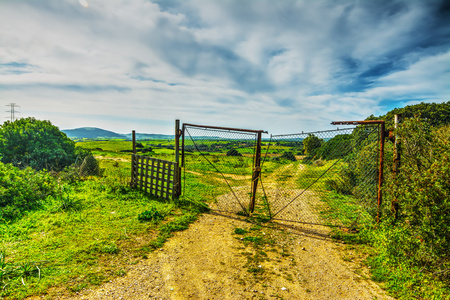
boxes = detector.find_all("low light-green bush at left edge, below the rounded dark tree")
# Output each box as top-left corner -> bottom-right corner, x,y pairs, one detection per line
0,162 -> 55,220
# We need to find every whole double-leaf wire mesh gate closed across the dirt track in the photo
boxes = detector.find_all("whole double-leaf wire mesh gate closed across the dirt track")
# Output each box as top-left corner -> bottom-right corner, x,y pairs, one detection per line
182,124 -> 380,227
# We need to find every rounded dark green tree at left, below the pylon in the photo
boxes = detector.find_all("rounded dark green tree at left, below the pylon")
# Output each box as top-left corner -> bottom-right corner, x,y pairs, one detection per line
0,118 -> 83,171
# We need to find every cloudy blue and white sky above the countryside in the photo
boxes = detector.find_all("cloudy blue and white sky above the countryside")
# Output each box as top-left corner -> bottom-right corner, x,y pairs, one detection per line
0,0 -> 450,134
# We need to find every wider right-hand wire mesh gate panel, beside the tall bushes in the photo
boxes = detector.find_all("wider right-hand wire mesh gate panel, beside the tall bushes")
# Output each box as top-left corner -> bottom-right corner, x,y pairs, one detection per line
259,126 -> 379,226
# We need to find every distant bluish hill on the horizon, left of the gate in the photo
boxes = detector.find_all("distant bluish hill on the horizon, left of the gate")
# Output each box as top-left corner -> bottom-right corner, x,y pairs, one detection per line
61,127 -> 175,140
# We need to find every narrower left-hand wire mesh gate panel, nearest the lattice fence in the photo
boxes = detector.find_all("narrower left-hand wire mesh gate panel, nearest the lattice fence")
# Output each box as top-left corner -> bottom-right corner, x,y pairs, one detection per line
182,124 -> 260,214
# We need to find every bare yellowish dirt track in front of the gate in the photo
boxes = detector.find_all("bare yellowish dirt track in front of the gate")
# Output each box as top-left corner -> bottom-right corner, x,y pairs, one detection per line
50,213 -> 392,299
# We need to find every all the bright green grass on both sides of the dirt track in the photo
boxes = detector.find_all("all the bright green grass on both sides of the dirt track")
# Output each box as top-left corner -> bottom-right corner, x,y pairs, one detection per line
0,140 -> 446,299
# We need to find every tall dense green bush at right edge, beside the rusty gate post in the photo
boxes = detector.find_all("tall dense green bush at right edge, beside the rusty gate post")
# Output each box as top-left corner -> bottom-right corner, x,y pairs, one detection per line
385,118 -> 450,269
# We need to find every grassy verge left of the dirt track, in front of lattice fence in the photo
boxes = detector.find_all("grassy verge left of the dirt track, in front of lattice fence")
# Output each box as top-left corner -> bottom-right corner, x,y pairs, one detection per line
0,155 -> 204,299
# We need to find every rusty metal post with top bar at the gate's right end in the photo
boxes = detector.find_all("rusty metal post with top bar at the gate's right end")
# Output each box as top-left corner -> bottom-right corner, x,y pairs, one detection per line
331,120 -> 386,223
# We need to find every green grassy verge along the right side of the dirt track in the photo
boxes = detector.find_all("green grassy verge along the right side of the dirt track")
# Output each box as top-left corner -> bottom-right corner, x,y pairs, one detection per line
322,193 -> 450,299
